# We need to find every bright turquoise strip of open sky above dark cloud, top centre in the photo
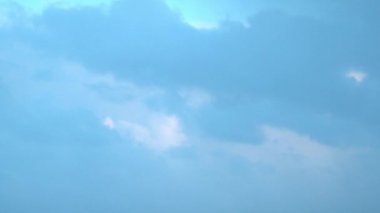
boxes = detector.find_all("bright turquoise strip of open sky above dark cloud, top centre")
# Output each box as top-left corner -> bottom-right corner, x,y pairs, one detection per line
165,0 -> 323,30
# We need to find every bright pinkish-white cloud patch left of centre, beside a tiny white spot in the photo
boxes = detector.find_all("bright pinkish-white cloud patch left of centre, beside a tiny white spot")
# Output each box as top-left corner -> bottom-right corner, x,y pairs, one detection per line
118,115 -> 187,151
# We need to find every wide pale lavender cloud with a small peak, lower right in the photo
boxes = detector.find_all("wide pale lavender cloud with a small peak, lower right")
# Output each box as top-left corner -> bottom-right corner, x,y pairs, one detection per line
225,126 -> 351,169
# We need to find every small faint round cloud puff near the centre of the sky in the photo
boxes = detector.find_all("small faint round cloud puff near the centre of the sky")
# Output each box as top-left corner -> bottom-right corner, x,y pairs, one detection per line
178,88 -> 214,108
